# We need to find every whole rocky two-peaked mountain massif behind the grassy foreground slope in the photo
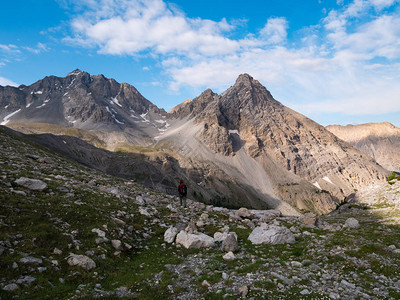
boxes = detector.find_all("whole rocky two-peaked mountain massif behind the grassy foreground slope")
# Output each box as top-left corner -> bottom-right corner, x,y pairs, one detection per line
0,70 -> 387,214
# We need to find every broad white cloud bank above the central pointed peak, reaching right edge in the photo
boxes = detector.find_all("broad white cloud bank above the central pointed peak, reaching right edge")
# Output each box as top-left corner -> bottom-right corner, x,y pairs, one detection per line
64,0 -> 400,114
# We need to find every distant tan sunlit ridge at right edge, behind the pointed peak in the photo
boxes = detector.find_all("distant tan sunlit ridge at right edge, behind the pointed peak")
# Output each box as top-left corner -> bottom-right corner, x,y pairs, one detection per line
326,122 -> 400,172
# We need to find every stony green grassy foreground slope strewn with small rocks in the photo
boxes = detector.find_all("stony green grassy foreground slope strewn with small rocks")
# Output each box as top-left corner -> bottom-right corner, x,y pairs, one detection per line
0,129 -> 400,299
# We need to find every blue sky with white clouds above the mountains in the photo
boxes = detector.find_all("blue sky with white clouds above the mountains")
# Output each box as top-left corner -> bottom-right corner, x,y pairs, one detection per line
0,0 -> 400,126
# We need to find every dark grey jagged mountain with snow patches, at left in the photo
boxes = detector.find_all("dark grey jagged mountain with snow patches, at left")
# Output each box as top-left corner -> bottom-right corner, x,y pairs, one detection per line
0,70 -> 167,136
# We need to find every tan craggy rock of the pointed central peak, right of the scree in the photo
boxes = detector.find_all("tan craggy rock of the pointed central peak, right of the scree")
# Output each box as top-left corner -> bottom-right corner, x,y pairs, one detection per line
167,74 -> 388,212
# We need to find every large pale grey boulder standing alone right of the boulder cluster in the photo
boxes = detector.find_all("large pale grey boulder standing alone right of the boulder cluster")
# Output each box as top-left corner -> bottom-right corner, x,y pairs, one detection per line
249,225 -> 295,245
